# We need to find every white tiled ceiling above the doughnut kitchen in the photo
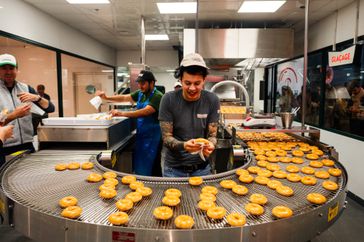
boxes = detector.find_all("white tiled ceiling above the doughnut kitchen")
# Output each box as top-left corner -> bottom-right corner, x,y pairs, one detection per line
24,0 -> 354,50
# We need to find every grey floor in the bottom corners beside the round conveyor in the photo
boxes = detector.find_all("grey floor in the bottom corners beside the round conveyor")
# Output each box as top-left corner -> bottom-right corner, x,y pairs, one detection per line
0,197 -> 364,242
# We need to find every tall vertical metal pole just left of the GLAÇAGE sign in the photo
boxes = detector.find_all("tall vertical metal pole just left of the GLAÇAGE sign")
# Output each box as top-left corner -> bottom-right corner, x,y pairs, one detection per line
301,0 -> 310,129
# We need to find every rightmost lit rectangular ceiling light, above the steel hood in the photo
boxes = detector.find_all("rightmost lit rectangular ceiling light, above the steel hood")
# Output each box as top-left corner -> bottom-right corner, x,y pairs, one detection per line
238,1 -> 286,13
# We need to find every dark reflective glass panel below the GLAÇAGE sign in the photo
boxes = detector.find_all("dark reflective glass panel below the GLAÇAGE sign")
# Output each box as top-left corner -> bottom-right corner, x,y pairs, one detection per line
324,45 -> 364,137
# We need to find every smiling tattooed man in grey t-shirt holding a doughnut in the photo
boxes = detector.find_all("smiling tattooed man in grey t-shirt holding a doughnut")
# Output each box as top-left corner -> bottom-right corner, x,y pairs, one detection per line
159,53 -> 220,177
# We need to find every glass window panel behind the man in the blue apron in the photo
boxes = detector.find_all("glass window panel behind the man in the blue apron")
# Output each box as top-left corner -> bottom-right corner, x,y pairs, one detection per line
61,54 -> 114,117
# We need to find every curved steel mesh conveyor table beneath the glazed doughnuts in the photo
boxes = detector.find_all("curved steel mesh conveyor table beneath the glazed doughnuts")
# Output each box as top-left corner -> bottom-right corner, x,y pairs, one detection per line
0,136 -> 347,242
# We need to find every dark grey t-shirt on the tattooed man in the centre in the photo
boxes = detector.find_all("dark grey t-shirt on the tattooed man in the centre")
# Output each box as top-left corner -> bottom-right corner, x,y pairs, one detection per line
159,90 -> 220,167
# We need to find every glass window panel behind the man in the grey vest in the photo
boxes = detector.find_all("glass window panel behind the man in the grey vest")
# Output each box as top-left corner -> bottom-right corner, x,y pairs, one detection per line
0,36 -> 58,117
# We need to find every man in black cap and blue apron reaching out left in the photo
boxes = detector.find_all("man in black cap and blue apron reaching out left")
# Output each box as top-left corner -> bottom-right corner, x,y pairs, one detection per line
96,70 -> 163,176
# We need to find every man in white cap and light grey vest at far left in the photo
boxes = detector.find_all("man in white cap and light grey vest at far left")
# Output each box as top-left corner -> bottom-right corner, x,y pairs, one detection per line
0,54 -> 54,166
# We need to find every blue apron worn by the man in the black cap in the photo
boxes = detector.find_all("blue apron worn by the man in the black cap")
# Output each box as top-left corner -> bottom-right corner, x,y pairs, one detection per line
133,88 -> 161,176
